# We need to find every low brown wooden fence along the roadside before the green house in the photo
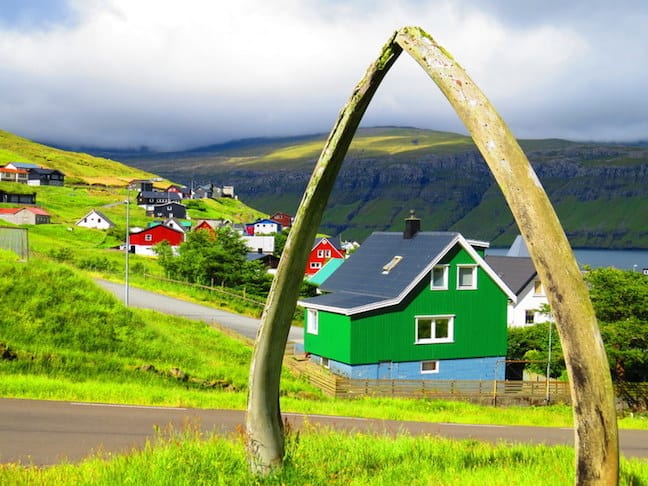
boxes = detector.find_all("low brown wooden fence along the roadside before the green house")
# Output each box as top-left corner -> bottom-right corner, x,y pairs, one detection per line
285,357 -> 571,405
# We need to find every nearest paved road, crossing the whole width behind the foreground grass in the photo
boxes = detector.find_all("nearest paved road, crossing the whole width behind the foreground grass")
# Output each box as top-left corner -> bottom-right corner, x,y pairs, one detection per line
0,399 -> 648,466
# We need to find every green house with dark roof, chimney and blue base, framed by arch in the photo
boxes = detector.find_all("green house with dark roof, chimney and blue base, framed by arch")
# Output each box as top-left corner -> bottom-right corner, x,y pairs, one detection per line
300,218 -> 516,380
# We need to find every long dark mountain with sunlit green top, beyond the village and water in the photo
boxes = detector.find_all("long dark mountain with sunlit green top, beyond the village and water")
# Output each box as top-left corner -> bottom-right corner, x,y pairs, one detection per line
73,127 -> 648,249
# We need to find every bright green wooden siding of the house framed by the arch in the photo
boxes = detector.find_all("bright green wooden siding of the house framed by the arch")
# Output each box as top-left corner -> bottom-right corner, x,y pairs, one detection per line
304,246 -> 507,365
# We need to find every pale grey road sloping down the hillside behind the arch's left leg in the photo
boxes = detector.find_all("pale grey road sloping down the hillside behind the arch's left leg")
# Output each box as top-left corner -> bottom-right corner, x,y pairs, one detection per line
95,279 -> 304,342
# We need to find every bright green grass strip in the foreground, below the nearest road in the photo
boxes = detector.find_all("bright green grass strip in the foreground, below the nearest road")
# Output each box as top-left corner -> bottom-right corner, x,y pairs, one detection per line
0,424 -> 648,486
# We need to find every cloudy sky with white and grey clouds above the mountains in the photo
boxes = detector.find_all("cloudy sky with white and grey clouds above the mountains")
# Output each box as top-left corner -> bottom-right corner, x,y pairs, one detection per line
0,0 -> 648,150
